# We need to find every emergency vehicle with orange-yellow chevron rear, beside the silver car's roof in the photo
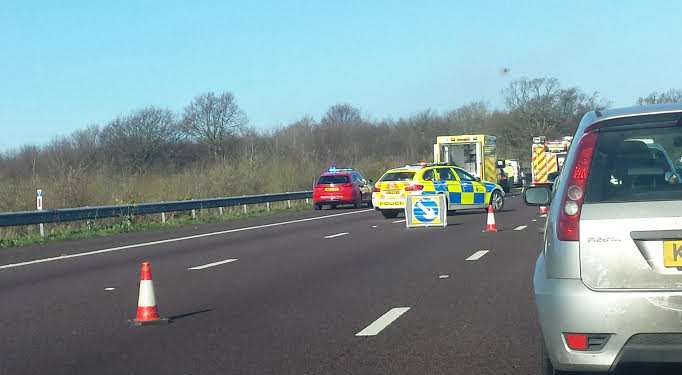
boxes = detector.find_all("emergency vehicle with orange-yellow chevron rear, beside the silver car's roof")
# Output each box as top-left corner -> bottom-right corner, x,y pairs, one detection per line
531,136 -> 573,185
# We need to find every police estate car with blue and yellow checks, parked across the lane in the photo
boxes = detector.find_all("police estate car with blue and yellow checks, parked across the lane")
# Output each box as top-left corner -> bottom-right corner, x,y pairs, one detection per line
372,163 -> 504,218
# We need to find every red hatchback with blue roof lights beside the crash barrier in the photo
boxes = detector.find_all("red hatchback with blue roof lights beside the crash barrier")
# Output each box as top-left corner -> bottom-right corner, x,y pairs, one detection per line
313,167 -> 372,210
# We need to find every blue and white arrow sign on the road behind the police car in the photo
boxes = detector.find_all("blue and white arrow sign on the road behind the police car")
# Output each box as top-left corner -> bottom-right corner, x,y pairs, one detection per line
405,194 -> 448,228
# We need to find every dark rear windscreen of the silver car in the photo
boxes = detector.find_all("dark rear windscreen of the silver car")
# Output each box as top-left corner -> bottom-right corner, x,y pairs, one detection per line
585,122 -> 682,203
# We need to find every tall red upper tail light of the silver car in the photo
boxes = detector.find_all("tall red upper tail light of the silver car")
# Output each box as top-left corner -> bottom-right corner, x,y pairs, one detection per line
557,132 -> 599,241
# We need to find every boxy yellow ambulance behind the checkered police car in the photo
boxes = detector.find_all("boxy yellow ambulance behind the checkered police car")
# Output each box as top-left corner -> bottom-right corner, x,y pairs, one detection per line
433,134 -> 499,187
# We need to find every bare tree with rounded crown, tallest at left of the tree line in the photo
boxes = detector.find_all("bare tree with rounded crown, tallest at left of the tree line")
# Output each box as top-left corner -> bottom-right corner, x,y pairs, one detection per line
182,91 -> 247,159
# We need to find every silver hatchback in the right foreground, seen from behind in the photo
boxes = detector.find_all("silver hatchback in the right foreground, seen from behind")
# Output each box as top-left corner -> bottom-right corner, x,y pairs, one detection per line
524,105 -> 682,374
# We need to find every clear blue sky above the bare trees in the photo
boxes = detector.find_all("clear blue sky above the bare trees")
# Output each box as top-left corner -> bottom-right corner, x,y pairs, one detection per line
0,0 -> 682,150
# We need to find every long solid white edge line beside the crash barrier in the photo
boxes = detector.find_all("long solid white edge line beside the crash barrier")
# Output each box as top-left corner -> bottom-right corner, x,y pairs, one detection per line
0,209 -> 374,270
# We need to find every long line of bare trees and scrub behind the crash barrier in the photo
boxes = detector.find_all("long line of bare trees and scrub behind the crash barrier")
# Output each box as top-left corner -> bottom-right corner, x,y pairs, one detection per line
0,78 -> 682,211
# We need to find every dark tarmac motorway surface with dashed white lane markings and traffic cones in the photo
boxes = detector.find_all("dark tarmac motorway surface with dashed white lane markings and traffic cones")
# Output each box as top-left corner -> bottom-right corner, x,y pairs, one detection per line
0,196 -> 544,375
